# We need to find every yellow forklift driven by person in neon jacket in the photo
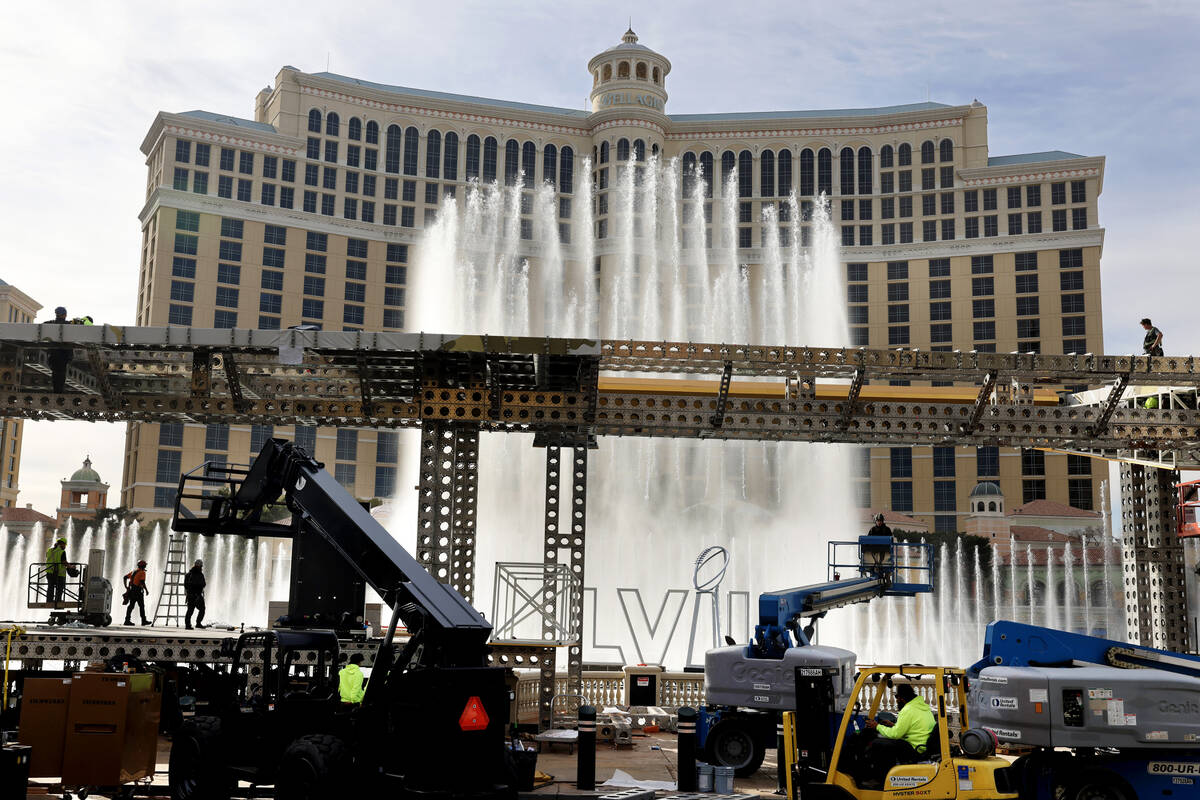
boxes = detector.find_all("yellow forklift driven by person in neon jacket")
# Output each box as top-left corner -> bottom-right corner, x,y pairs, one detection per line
782,664 -> 1018,800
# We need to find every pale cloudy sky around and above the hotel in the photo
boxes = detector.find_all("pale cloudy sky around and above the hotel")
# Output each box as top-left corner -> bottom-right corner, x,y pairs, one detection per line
0,0 -> 1200,513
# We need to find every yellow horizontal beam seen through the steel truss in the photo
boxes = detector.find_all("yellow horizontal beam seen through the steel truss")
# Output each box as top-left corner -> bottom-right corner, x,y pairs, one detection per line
600,375 -> 1058,405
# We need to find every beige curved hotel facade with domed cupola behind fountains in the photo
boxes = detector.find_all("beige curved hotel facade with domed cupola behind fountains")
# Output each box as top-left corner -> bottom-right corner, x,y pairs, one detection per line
121,31 -> 1106,530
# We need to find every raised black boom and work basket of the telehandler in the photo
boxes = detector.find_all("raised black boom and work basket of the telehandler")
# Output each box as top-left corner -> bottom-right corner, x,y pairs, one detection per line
172,439 -> 492,671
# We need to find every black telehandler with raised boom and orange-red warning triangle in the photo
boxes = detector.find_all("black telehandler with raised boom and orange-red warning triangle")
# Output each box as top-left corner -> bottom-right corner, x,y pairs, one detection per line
170,439 -> 516,800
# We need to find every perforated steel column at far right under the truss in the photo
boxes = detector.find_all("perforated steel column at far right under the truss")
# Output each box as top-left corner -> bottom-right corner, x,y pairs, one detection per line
1121,463 -> 1188,651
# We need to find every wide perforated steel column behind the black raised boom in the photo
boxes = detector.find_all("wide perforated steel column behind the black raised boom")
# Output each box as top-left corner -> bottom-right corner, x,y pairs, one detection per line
416,422 -> 479,601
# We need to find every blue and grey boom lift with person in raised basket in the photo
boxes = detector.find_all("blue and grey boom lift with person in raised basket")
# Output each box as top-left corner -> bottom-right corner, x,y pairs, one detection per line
696,536 -> 935,777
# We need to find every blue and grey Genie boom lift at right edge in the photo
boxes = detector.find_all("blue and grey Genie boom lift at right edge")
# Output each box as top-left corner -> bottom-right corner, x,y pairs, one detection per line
967,621 -> 1200,800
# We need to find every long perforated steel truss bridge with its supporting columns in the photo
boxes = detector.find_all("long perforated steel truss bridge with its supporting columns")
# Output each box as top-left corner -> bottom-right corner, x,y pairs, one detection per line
0,324 -> 1200,690
